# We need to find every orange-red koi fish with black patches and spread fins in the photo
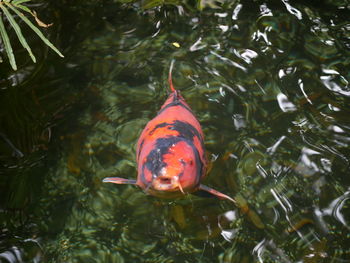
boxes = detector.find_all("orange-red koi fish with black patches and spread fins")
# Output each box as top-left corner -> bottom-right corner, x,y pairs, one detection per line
103,62 -> 235,203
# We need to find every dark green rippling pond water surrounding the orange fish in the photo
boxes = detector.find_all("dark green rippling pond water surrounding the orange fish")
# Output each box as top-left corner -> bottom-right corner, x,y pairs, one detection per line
0,0 -> 350,263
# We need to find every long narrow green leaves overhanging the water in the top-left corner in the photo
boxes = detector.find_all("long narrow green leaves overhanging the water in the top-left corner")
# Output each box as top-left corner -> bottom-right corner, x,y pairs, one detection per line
0,0 -> 63,70
